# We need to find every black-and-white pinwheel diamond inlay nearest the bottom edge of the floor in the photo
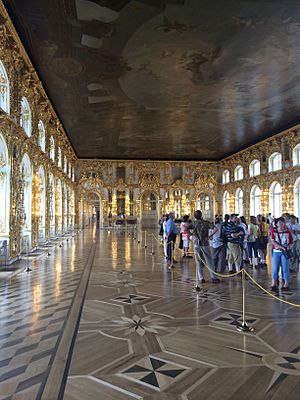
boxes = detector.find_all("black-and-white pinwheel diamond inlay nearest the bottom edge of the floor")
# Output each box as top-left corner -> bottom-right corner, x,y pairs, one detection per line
118,355 -> 190,391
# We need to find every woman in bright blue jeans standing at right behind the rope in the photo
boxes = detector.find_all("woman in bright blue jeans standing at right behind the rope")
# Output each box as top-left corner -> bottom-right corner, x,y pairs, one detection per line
271,217 -> 293,291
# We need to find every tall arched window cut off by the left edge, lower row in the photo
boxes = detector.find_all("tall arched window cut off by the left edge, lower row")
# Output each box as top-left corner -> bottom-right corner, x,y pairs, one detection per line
0,134 -> 10,237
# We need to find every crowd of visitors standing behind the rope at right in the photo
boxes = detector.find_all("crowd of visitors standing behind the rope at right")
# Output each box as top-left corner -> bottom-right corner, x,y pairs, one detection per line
160,210 -> 300,291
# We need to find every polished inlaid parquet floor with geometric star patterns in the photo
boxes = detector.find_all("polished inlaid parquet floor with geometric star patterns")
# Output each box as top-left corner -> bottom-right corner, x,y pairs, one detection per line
0,229 -> 300,400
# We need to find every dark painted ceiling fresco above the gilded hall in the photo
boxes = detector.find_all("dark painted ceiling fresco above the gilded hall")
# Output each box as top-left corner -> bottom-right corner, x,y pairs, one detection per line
4,0 -> 300,160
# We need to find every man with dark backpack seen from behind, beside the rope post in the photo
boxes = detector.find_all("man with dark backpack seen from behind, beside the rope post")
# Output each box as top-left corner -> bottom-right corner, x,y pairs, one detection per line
188,210 -> 220,283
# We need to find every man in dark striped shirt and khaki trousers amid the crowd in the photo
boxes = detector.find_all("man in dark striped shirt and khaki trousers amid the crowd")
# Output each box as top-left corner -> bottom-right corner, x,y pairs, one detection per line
225,214 -> 245,274
